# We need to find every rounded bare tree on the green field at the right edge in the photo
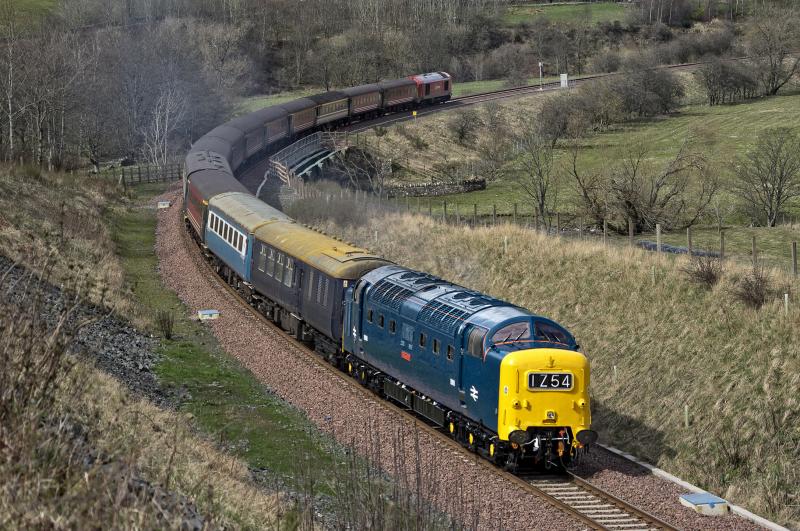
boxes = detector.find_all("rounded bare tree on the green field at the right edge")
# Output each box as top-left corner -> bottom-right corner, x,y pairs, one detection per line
734,128 -> 800,227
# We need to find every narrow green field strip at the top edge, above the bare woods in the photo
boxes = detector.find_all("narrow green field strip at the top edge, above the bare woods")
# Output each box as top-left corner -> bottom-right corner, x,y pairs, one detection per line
503,2 -> 628,24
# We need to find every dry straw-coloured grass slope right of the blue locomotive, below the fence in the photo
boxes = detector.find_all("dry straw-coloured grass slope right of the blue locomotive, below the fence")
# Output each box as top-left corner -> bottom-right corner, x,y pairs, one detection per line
304,205 -> 800,527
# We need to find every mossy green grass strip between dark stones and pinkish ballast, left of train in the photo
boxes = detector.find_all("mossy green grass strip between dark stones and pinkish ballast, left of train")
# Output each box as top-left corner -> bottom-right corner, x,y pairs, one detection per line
113,185 -> 334,480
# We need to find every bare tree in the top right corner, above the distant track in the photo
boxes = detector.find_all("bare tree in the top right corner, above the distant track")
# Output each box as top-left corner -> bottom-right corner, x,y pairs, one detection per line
749,6 -> 800,95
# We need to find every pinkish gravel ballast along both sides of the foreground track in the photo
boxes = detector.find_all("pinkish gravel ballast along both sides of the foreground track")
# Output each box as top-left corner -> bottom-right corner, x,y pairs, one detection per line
156,185 -> 768,530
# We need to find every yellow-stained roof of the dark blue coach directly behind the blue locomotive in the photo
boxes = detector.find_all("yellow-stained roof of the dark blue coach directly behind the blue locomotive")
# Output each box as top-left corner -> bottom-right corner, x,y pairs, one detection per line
255,222 -> 390,280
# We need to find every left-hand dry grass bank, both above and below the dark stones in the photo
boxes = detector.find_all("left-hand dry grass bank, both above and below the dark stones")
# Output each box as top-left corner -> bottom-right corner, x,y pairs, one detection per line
0,167 -> 284,529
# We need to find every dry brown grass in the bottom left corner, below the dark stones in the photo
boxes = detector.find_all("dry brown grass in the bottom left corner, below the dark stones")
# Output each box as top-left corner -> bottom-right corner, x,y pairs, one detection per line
0,264 -> 290,529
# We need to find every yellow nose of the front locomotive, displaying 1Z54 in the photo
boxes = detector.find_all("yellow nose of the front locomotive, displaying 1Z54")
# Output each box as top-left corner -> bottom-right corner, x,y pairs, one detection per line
497,348 -> 592,446
